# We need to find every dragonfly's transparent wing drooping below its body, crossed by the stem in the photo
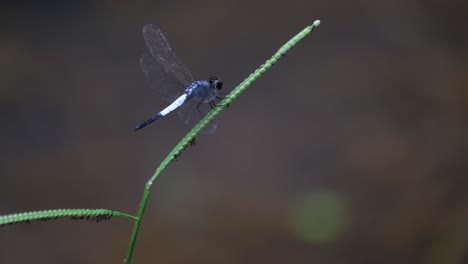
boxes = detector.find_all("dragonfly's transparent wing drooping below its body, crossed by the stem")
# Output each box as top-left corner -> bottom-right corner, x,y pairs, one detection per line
179,98 -> 218,134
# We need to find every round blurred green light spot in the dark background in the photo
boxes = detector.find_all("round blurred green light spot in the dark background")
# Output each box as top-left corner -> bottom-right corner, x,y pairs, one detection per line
288,190 -> 349,243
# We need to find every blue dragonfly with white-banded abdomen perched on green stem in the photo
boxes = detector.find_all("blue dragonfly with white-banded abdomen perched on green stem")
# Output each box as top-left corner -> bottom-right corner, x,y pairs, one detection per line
134,24 -> 223,134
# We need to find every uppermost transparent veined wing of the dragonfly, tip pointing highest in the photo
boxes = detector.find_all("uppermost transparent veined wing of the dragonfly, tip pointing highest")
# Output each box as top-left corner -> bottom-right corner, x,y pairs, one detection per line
142,24 -> 193,87
